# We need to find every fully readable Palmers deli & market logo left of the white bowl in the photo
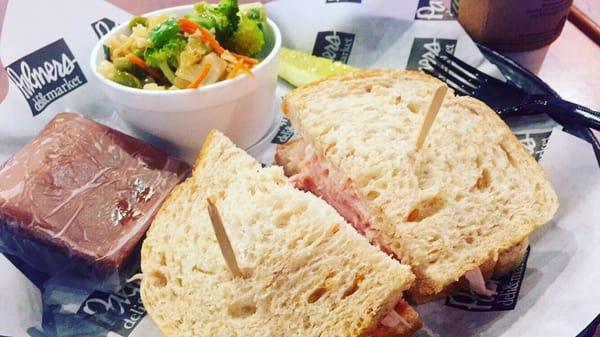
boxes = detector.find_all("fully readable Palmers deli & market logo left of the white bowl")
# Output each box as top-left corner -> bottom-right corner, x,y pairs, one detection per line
6,39 -> 87,116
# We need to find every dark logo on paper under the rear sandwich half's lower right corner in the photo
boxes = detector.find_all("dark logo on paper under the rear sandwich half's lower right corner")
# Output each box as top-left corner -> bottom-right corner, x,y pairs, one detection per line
446,247 -> 530,311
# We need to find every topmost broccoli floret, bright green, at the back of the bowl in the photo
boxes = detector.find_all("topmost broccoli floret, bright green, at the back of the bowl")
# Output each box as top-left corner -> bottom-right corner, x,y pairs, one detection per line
189,0 -> 240,42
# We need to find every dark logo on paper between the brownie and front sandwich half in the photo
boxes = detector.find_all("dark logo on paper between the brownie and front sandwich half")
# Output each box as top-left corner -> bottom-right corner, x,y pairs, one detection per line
77,281 -> 146,337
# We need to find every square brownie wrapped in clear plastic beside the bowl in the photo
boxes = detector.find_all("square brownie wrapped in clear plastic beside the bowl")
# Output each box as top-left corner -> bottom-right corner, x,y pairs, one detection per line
0,113 -> 190,274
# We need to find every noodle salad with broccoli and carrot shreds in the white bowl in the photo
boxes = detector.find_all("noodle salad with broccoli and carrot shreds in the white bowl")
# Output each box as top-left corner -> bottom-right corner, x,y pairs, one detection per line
98,0 -> 273,90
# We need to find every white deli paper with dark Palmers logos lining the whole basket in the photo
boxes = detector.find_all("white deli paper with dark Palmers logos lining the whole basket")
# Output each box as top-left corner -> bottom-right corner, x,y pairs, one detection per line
0,0 -> 600,337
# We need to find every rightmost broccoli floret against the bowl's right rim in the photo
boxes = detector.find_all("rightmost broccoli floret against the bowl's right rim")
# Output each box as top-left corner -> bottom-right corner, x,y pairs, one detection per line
225,16 -> 265,56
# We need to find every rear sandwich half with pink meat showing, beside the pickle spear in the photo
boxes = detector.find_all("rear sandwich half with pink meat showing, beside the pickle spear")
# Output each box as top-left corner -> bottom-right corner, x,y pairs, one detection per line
276,70 -> 558,302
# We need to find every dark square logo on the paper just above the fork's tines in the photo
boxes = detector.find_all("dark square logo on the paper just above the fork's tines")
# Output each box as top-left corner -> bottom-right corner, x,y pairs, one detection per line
406,38 -> 456,70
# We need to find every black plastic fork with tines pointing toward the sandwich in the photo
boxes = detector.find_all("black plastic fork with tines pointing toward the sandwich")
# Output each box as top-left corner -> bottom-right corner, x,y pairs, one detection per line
424,51 -> 600,130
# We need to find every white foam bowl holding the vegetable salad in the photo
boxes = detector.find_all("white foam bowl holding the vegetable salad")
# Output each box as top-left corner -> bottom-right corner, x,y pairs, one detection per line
90,5 -> 281,160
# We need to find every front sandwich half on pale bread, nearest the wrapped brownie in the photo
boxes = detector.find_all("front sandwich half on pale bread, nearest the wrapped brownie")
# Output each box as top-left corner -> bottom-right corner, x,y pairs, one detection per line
141,131 -> 421,337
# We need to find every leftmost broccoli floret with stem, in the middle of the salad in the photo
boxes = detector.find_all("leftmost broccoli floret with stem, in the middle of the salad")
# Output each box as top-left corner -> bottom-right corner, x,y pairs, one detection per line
144,36 -> 187,83
